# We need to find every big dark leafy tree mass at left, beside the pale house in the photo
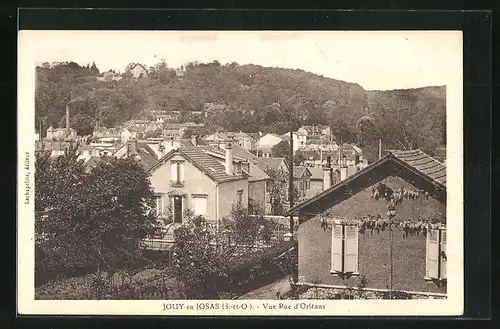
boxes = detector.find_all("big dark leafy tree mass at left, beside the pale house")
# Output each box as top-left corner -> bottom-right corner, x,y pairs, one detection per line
35,146 -> 154,275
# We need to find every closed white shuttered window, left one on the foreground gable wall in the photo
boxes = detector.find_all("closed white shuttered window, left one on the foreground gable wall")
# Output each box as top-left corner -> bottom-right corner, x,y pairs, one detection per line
330,224 -> 359,277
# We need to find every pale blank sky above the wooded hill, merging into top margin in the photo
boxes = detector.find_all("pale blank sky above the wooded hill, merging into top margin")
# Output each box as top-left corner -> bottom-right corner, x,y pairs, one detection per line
19,31 -> 462,90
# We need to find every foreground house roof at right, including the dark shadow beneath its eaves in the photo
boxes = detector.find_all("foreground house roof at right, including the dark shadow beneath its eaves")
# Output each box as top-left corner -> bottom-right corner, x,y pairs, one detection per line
285,149 -> 446,216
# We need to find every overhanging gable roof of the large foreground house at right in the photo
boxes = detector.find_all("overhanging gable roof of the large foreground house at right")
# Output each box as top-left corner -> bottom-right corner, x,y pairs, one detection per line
285,149 -> 446,215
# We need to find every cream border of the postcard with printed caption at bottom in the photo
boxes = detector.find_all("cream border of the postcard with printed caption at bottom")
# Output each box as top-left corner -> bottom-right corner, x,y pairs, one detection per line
17,31 -> 464,316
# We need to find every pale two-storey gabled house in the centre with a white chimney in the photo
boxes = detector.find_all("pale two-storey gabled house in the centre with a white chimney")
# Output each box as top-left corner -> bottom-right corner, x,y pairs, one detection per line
149,142 -> 248,227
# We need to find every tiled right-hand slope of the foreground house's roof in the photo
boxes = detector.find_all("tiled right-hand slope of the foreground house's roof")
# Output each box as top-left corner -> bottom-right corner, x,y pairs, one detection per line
391,149 -> 446,186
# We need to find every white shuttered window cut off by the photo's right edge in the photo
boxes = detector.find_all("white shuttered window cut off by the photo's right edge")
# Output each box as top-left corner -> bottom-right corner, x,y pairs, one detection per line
425,229 -> 446,280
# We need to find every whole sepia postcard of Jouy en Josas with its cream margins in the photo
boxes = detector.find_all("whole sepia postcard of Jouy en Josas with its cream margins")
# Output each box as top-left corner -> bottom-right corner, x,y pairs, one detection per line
18,31 -> 463,316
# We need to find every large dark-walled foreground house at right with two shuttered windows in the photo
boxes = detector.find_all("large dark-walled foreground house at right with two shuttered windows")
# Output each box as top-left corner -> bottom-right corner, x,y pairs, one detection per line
286,150 -> 446,296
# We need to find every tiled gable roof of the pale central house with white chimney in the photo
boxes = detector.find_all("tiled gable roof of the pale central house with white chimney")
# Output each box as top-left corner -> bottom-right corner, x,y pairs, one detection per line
149,146 -> 246,183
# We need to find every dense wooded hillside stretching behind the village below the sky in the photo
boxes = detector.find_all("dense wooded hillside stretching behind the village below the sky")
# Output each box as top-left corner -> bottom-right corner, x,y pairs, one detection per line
35,61 -> 446,160
